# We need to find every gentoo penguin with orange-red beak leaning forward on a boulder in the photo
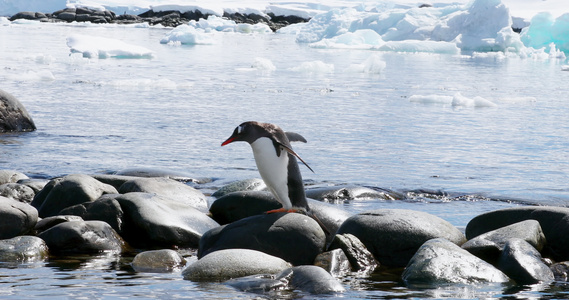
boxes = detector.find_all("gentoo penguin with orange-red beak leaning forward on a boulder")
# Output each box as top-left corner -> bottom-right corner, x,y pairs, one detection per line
221,121 -> 314,213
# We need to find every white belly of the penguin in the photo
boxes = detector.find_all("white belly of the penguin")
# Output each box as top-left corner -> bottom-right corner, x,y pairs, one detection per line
251,137 -> 292,209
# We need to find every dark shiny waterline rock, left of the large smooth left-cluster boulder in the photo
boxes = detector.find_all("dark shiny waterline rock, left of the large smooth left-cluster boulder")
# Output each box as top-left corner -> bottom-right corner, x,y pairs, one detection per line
38,221 -> 126,253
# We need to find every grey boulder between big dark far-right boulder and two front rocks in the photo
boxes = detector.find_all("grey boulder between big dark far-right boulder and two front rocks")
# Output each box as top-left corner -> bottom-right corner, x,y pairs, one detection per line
462,220 -> 545,264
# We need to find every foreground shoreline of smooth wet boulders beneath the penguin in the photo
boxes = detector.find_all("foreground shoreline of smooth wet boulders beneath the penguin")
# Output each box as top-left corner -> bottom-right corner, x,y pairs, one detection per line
0,169 -> 569,294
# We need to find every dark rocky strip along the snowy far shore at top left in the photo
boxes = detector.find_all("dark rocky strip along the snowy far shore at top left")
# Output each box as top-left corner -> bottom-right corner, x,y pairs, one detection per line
9,7 -> 309,31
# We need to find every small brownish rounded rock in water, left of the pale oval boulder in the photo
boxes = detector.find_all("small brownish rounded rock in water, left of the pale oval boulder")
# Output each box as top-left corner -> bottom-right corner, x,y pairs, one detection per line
131,249 -> 186,273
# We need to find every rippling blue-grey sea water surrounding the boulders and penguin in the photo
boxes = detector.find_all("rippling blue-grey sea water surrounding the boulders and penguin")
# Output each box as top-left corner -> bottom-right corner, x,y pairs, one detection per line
0,23 -> 569,299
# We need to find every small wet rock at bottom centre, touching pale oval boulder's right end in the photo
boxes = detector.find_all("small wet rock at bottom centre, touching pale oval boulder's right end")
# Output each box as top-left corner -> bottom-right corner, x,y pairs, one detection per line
276,266 -> 345,294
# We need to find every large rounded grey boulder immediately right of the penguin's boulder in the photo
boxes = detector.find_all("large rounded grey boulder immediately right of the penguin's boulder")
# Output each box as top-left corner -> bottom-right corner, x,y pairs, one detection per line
337,209 -> 466,267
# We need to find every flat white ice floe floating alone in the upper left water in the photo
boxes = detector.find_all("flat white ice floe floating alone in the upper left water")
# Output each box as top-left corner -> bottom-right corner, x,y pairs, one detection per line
67,34 -> 154,59
